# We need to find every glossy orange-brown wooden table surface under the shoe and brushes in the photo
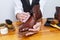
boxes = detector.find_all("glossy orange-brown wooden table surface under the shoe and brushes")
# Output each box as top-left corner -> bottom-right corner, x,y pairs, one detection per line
0,20 -> 60,40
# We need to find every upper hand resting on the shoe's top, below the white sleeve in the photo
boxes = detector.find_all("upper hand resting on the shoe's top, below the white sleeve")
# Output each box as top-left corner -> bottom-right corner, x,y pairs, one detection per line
17,12 -> 30,23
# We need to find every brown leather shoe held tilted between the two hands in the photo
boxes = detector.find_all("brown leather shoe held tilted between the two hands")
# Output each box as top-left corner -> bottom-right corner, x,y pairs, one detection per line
19,5 -> 42,35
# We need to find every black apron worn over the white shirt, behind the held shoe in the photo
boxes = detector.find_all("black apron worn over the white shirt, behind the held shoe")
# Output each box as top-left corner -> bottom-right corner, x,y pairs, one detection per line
21,0 -> 40,15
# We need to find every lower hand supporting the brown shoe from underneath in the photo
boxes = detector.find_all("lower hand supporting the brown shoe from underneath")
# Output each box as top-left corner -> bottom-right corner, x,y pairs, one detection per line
25,22 -> 41,36
